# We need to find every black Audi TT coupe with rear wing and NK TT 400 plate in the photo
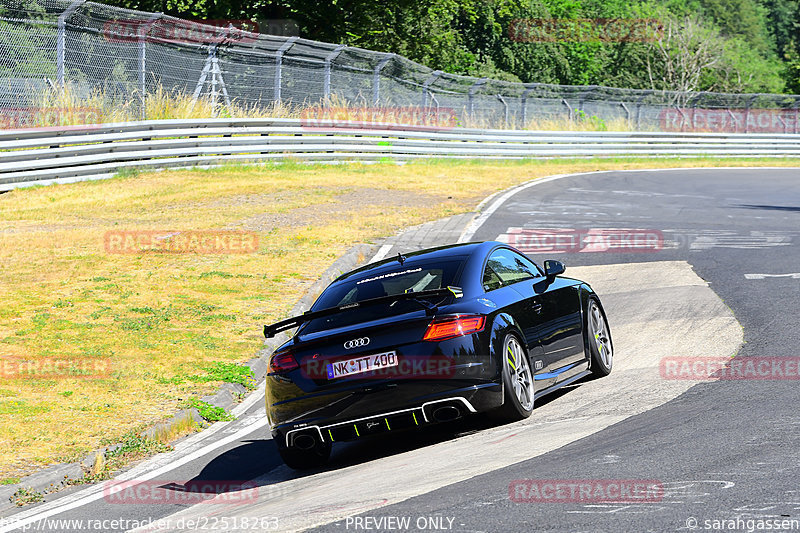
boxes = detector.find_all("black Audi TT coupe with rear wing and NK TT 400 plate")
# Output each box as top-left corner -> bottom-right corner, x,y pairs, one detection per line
264,242 -> 613,468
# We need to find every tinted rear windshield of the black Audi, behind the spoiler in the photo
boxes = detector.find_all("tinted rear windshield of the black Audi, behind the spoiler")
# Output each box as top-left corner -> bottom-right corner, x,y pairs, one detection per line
303,258 -> 465,333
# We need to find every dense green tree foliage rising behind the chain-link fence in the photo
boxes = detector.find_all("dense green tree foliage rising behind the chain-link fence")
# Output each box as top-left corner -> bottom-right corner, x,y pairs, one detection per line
100,0 -> 800,92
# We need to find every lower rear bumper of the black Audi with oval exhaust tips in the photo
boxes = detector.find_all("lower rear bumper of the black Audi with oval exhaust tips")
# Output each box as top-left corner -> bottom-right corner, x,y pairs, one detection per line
268,378 -> 503,446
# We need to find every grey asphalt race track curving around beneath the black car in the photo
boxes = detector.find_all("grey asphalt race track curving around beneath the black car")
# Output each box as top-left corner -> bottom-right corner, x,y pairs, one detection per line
0,169 -> 800,532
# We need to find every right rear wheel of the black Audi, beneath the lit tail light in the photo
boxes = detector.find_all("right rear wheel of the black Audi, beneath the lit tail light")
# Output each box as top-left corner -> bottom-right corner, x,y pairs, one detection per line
496,333 -> 534,421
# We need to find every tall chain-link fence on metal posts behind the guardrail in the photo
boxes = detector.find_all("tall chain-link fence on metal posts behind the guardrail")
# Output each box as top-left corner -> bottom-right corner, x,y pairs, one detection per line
0,0 -> 800,133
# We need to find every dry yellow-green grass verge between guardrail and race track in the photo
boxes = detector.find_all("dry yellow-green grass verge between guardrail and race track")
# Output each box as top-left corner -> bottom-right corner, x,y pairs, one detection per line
0,159 -> 800,479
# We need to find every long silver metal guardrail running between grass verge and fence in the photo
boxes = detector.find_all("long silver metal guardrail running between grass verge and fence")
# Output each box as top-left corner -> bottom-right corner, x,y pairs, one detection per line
0,118 -> 800,190
